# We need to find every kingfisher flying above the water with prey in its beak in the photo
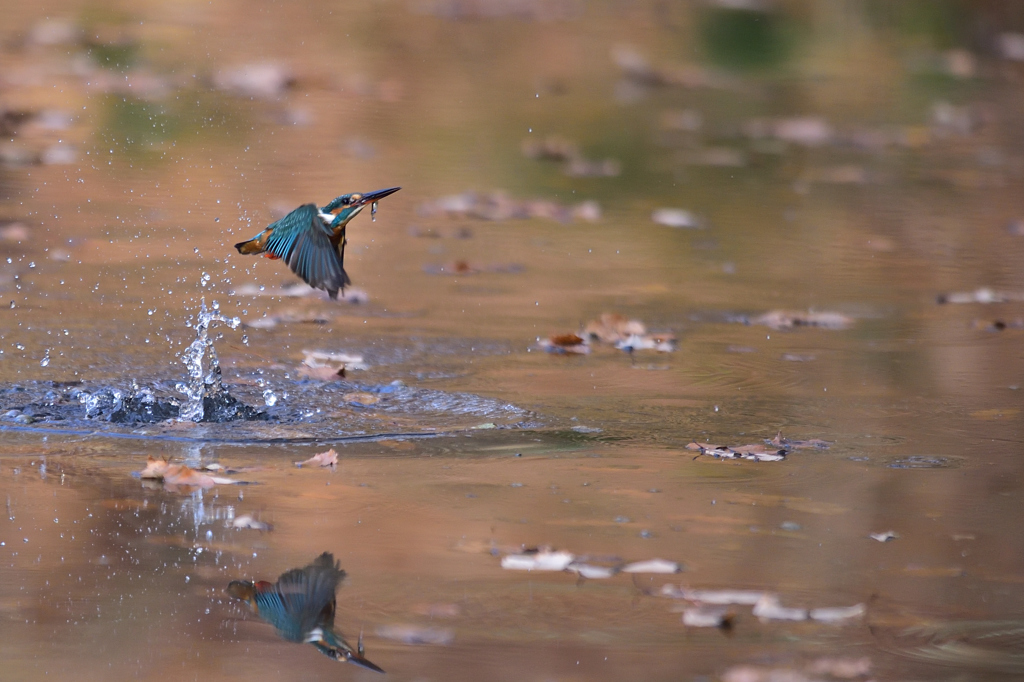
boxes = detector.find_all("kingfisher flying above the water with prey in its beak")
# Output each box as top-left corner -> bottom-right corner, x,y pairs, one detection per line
234,187 -> 401,299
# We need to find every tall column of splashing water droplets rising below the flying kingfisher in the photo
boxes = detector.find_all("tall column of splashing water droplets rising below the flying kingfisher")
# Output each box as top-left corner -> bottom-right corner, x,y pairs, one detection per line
177,298 -> 242,422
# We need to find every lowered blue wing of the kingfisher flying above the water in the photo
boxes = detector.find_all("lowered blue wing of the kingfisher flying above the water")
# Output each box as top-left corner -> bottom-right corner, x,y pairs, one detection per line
264,204 -> 349,298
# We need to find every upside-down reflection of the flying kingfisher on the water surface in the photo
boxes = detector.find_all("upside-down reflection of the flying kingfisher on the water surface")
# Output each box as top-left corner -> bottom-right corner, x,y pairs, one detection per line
225,552 -> 384,673
